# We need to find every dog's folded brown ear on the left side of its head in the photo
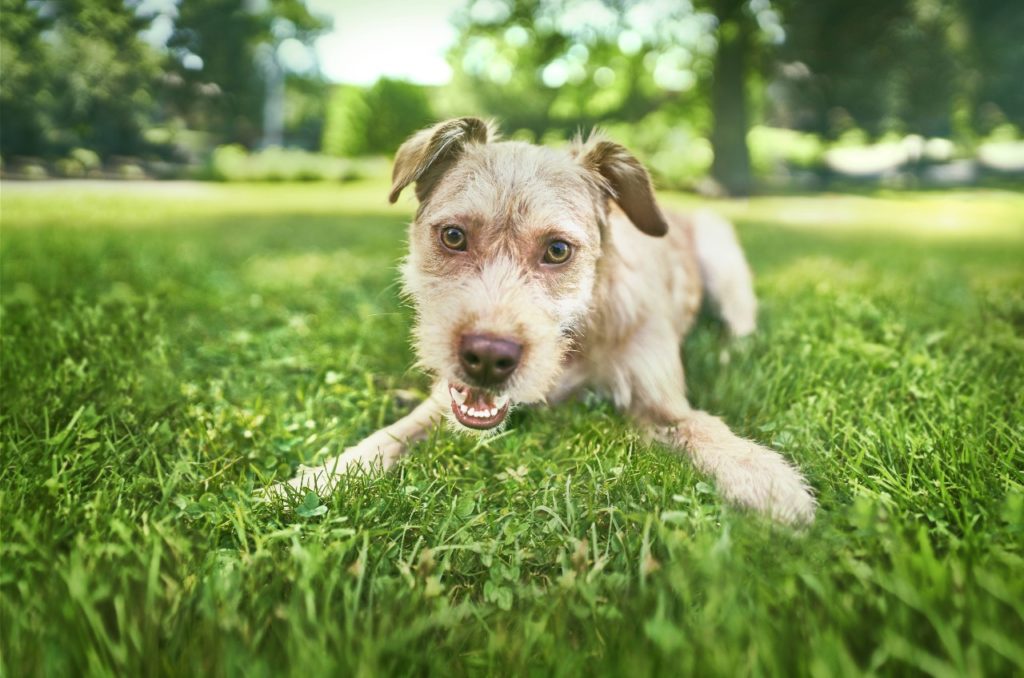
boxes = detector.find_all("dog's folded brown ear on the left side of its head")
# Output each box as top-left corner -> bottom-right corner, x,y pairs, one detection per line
388,118 -> 495,203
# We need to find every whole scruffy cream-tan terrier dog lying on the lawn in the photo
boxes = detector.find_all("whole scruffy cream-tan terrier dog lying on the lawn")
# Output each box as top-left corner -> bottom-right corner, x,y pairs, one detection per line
276,118 -> 815,523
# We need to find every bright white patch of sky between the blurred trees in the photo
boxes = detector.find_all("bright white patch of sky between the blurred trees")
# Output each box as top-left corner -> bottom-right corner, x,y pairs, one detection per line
306,0 -> 466,85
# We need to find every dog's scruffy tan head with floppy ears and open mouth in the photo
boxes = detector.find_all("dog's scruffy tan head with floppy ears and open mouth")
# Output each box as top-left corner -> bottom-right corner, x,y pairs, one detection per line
390,118 -> 668,430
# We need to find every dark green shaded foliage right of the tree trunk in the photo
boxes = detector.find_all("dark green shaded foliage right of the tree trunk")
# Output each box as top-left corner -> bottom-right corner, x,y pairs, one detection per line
774,0 -> 1024,140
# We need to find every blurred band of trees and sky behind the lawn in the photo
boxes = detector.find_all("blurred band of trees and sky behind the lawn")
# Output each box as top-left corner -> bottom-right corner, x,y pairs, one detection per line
0,0 -> 1024,196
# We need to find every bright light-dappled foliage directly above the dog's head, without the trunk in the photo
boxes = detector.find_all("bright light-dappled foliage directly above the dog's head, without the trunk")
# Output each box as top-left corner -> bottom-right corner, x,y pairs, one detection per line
450,0 -> 714,139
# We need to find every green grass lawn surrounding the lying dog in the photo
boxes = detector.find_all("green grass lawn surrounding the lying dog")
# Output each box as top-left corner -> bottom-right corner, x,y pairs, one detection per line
6,183 -> 1024,676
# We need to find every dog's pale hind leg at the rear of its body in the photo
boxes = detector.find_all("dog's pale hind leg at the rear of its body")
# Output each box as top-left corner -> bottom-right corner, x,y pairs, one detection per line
693,211 -> 758,337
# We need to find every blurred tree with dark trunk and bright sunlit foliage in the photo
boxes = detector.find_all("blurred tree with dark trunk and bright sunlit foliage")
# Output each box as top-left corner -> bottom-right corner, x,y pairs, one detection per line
451,0 -> 770,195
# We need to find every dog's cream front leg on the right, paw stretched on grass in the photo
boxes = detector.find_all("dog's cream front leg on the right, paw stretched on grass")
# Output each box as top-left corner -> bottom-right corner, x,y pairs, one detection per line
616,323 -> 816,523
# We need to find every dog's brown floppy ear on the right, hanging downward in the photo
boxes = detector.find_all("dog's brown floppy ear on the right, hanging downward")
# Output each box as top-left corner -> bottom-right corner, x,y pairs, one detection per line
573,135 -> 669,236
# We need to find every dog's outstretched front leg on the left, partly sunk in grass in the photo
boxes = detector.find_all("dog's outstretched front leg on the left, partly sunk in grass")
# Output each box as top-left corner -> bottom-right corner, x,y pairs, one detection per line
268,385 -> 451,496
